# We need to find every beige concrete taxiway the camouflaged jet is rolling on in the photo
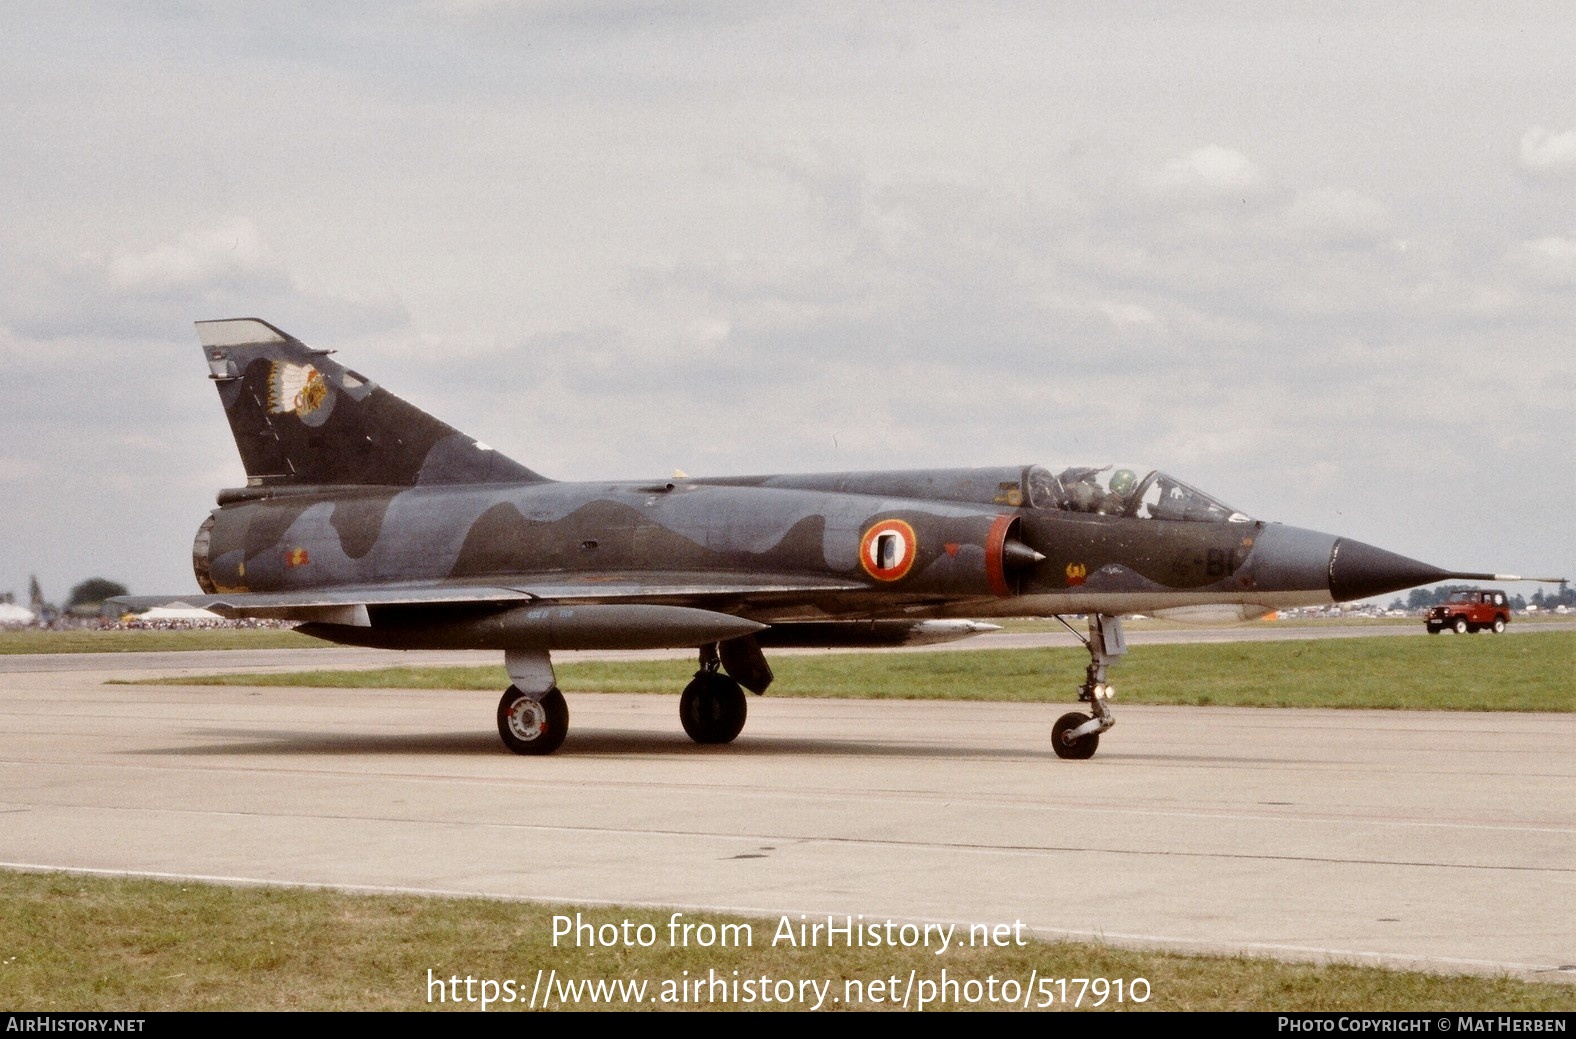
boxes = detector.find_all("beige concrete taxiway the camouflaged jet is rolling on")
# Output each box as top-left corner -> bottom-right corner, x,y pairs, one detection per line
0,621 -> 1576,982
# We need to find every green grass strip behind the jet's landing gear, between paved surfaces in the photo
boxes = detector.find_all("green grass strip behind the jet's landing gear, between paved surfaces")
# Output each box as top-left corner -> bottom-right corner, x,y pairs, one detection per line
129,631 -> 1576,711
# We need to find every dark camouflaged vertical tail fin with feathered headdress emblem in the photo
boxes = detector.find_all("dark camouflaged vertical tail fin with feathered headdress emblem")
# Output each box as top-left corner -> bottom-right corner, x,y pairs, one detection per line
197,317 -> 547,489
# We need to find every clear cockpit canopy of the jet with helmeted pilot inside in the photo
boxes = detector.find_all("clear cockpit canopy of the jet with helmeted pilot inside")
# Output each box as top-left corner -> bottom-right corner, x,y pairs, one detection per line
1023,465 -> 1253,523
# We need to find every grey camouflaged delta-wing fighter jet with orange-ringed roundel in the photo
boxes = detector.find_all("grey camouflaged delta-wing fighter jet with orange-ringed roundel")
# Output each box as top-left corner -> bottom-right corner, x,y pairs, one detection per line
118,318 -> 1538,758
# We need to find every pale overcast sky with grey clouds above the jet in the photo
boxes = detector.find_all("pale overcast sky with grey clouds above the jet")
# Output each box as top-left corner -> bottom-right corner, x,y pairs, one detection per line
0,0 -> 1576,601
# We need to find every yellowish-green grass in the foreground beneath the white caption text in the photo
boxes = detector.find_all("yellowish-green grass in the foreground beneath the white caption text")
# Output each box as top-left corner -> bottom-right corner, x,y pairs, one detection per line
0,873 -> 1576,1012
